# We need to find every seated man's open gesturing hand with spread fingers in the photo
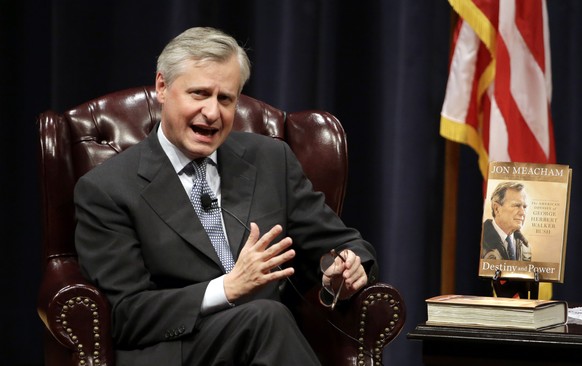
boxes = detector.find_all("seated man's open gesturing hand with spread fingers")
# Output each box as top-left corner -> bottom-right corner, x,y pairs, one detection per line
224,222 -> 295,302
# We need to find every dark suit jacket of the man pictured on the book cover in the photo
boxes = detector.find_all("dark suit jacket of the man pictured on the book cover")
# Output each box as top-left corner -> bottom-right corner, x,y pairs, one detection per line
481,219 -> 531,261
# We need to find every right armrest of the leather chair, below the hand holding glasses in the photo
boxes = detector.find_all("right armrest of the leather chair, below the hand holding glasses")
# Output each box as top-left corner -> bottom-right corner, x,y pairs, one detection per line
299,283 -> 406,365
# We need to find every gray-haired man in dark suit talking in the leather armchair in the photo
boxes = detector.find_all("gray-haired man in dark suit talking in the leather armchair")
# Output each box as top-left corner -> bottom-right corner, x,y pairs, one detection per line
75,28 -> 377,366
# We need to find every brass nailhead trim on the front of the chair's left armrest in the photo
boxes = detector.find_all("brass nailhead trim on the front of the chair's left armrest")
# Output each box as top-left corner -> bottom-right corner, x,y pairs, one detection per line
57,296 -> 101,366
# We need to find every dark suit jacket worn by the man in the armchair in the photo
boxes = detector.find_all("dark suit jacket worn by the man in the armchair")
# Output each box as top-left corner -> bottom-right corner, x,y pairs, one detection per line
75,125 -> 377,364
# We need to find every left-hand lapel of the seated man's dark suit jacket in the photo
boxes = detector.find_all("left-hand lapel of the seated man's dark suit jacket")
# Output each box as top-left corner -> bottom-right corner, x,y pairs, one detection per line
138,128 -> 222,267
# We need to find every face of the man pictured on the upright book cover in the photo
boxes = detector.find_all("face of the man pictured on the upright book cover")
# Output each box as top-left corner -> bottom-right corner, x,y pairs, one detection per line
493,189 -> 527,235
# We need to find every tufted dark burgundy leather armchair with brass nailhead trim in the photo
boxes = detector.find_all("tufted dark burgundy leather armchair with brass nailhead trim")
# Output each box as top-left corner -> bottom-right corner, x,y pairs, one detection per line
37,87 -> 406,366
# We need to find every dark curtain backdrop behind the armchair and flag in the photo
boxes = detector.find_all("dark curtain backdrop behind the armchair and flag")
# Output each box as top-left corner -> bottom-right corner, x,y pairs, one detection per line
0,0 -> 582,366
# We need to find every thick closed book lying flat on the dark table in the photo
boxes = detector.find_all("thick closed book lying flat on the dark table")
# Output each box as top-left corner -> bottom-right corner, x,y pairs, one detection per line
426,295 -> 568,330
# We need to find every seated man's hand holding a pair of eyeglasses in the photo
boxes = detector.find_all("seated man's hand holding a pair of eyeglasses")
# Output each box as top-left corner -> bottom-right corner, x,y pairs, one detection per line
322,249 -> 368,300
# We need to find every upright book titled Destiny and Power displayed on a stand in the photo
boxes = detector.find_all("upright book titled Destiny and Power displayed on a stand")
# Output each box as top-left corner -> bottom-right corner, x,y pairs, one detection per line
478,162 -> 572,282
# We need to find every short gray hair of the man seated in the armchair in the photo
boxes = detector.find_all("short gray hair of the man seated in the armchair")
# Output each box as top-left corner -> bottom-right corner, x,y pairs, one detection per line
157,27 -> 251,93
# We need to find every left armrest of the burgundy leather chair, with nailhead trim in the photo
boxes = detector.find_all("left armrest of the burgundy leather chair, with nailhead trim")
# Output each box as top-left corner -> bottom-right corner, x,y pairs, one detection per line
37,256 -> 115,366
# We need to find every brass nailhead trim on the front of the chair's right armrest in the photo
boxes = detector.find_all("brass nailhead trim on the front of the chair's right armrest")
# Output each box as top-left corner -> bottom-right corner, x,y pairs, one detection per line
358,293 -> 400,366
